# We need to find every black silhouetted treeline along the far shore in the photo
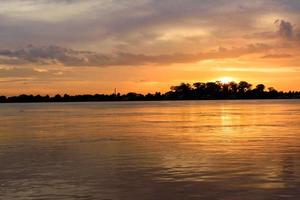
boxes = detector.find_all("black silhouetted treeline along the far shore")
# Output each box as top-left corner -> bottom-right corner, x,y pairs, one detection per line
0,81 -> 300,103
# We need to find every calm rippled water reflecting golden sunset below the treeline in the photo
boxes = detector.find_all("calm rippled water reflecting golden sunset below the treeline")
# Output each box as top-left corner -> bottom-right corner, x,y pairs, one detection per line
0,100 -> 300,200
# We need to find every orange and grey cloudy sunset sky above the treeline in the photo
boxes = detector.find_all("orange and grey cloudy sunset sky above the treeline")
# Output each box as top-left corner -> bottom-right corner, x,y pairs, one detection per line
0,0 -> 300,95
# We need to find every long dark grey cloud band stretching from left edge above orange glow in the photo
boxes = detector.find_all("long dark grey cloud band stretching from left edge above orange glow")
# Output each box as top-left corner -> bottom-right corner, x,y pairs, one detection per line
0,43 -> 271,67
